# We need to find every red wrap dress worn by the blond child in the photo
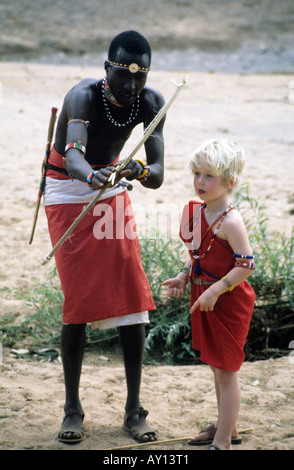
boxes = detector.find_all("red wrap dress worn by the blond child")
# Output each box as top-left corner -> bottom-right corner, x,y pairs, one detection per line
181,201 -> 256,371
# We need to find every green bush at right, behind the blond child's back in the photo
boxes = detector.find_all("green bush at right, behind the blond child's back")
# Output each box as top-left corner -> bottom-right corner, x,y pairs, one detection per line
236,184 -> 294,360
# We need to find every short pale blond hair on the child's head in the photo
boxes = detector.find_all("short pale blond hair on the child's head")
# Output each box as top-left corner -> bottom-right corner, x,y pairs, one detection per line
190,139 -> 245,192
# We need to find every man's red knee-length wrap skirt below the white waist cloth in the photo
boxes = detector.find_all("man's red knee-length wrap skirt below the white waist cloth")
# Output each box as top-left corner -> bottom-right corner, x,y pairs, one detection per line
45,191 -> 155,324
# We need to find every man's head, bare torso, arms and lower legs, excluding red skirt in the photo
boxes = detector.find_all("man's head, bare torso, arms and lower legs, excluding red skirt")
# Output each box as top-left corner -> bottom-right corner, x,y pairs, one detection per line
44,31 -> 164,443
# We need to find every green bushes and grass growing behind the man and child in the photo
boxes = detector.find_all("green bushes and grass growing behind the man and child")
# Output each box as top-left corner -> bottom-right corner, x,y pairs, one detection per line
0,185 -> 294,364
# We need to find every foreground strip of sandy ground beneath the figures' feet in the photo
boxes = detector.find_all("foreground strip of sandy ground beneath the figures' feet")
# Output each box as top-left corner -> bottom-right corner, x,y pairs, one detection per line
0,356 -> 293,452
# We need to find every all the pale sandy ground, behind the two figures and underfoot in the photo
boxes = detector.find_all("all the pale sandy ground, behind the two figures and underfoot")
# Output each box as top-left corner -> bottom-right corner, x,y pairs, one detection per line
0,0 -> 294,453
